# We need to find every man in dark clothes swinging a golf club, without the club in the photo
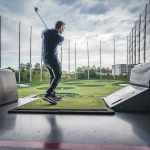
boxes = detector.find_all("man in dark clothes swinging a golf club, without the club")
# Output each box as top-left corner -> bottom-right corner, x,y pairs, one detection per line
42,21 -> 66,105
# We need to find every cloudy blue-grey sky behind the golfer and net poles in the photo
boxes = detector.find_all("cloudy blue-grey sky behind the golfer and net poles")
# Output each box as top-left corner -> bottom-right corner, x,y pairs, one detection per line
0,0 -> 148,71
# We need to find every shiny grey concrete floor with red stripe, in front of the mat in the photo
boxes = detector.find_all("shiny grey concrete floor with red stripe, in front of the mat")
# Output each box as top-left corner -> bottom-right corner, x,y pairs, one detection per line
0,103 -> 150,150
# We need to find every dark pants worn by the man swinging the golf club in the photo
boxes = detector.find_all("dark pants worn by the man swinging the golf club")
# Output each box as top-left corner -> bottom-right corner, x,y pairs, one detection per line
43,59 -> 62,96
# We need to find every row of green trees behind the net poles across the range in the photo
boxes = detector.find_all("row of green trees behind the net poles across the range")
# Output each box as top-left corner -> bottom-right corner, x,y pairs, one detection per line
8,63 -> 112,82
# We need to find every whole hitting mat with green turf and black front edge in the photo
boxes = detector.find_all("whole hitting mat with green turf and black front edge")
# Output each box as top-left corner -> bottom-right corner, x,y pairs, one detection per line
9,96 -> 114,114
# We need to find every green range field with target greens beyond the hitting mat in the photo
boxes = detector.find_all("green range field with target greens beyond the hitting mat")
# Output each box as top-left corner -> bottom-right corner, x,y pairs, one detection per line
18,80 -> 127,97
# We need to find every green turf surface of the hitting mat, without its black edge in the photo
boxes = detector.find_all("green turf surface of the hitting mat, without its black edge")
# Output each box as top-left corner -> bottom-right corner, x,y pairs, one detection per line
17,96 -> 107,110
